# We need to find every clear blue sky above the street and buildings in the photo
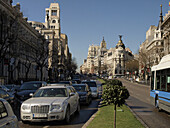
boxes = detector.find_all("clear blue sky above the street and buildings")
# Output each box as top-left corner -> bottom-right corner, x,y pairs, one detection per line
13,0 -> 169,69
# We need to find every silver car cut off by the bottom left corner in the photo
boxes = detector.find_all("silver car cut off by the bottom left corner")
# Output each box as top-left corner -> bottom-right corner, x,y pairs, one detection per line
0,98 -> 18,128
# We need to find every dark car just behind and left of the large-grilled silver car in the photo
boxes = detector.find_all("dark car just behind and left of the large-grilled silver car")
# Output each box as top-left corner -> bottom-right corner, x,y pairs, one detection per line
15,81 -> 47,105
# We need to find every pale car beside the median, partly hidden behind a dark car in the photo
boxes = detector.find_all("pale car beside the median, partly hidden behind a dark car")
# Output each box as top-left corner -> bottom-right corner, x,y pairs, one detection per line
82,80 -> 98,98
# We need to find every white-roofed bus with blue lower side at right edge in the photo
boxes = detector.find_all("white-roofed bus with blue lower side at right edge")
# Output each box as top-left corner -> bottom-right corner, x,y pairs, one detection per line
150,54 -> 170,112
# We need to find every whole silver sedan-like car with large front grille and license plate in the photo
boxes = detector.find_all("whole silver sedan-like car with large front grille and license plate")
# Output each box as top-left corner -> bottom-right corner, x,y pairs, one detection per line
21,84 -> 80,123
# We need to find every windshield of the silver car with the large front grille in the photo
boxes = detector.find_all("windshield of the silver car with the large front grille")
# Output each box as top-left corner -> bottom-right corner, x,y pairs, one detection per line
33,88 -> 67,97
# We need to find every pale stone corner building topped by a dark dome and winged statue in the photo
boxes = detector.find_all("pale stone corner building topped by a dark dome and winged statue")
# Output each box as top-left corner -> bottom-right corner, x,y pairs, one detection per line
105,36 -> 134,78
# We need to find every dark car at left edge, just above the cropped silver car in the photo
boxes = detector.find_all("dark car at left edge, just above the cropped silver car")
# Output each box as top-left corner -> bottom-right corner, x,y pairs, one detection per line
0,88 -> 14,107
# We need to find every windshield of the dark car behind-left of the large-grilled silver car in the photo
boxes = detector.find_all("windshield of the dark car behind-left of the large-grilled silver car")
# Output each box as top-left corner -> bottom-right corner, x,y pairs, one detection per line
20,83 -> 42,90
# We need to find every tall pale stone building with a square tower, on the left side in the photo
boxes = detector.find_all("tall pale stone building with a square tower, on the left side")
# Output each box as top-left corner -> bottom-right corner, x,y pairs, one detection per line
28,3 -> 72,80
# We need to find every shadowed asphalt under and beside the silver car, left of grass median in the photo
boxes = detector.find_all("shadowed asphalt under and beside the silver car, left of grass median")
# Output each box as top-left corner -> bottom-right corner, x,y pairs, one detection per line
16,82 -> 102,128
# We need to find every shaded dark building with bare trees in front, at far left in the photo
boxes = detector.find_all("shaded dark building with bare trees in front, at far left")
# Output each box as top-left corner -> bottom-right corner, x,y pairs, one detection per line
0,0 -> 48,84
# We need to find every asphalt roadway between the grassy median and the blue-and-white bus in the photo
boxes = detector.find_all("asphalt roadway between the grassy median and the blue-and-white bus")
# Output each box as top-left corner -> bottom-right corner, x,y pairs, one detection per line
120,79 -> 170,128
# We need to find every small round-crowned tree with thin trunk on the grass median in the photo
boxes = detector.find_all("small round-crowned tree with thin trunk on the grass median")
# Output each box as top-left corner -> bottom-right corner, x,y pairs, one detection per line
102,80 -> 129,128
